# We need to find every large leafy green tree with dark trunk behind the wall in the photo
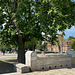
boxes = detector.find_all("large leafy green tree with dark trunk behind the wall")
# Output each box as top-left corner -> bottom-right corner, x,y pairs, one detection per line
0,0 -> 75,63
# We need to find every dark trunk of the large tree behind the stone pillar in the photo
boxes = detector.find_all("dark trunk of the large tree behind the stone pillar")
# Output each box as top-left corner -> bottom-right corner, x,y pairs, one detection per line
13,0 -> 25,64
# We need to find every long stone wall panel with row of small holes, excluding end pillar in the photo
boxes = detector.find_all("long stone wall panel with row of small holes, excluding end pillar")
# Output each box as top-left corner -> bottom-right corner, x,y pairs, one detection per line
36,55 -> 71,70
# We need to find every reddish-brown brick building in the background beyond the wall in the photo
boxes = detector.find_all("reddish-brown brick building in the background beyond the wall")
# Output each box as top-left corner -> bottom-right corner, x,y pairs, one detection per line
46,34 -> 71,52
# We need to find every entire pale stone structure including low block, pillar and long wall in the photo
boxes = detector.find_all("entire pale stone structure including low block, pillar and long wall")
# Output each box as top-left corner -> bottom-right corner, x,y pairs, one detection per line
16,51 -> 75,73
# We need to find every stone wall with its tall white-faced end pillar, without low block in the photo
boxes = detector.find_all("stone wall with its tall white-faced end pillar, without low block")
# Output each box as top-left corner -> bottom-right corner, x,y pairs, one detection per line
26,51 -> 75,71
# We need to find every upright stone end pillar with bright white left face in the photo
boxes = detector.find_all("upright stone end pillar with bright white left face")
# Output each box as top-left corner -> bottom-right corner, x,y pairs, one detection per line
26,51 -> 37,71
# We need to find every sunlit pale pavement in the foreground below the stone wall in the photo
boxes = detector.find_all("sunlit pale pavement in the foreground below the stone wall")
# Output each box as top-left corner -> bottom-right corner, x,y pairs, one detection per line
1,68 -> 75,75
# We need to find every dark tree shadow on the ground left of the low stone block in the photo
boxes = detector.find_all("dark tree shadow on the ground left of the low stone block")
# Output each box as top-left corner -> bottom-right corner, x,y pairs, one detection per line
0,61 -> 16,74
